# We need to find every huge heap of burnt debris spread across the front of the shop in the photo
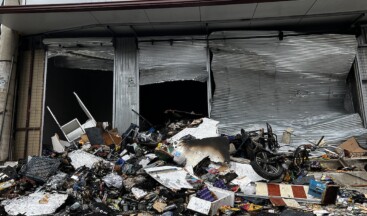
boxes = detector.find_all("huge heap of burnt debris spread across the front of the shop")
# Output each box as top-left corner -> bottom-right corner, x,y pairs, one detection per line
0,114 -> 367,216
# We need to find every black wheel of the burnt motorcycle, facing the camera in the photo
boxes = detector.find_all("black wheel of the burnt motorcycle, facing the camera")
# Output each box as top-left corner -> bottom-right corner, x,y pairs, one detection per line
250,151 -> 284,180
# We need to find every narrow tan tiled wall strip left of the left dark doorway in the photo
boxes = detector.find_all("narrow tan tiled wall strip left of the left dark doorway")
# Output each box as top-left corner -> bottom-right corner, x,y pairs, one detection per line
13,49 -> 45,160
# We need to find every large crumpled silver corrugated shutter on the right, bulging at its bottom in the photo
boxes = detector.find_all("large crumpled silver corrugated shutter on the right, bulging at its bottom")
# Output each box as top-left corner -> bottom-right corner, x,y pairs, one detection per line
210,32 -> 366,143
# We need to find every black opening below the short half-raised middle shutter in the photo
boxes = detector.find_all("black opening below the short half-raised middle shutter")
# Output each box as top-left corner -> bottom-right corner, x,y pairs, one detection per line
140,81 -> 208,128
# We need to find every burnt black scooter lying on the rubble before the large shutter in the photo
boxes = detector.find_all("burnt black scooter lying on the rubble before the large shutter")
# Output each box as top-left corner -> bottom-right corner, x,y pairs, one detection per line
237,123 -> 323,180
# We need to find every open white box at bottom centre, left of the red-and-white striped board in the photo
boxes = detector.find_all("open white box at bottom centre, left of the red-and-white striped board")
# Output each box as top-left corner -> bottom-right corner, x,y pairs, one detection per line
187,186 -> 234,215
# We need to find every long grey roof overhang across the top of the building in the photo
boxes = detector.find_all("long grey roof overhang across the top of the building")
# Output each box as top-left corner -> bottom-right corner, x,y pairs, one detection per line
0,0 -> 367,36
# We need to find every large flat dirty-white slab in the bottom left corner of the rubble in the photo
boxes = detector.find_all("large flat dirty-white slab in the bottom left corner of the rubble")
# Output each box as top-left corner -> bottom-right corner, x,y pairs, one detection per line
1,192 -> 68,215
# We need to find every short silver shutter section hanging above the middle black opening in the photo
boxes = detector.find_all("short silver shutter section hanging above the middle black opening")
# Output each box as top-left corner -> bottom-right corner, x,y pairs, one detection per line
139,37 -> 208,85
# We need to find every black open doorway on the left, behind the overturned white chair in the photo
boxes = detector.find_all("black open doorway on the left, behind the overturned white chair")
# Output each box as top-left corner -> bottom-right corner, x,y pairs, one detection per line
43,58 -> 113,147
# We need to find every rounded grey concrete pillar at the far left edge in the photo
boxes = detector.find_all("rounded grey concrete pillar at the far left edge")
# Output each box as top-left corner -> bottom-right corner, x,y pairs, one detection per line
0,0 -> 19,161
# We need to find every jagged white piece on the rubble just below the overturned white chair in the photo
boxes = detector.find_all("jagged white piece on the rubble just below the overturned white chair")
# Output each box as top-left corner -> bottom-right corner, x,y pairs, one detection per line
68,150 -> 104,169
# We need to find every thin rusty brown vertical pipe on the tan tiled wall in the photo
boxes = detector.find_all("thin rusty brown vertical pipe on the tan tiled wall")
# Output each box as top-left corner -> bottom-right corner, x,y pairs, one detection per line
24,40 -> 35,158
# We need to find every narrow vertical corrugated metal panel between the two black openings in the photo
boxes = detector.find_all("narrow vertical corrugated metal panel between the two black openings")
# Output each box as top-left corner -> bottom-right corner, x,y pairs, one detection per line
113,38 -> 139,132
